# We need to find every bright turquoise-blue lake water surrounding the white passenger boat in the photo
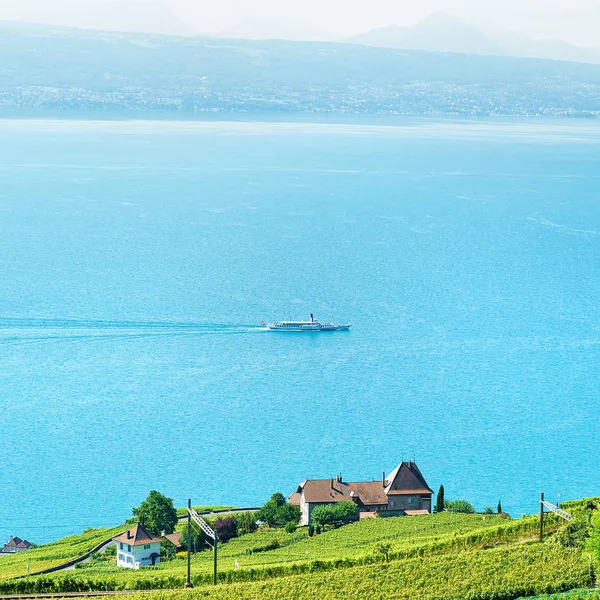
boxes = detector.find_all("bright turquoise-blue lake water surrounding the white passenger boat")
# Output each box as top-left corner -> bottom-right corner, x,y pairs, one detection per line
0,120 -> 600,543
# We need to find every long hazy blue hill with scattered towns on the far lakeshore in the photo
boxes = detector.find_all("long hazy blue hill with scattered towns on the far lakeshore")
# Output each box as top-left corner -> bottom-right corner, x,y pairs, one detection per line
0,23 -> 600,116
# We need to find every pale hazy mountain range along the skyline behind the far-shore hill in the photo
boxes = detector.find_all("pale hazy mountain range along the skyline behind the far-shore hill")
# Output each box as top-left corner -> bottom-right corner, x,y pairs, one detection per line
3,7 -> 600,64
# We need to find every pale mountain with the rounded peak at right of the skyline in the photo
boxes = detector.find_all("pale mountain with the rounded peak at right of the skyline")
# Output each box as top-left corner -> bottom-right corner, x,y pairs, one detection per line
343,13 -> 600,63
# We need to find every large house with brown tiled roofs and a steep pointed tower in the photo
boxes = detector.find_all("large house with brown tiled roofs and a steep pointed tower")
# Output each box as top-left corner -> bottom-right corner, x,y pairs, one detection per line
289,462 -> 433,525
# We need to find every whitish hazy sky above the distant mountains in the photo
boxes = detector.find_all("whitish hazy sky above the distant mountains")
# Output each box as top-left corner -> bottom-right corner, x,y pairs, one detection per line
0,0 -> 600,45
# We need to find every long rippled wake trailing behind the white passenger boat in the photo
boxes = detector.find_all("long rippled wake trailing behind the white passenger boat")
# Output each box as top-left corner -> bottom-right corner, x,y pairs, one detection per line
0,317 -> 264,346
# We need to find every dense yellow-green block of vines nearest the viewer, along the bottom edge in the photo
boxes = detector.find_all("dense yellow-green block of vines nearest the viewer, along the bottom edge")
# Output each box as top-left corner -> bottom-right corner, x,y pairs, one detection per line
70,544 -> 597,600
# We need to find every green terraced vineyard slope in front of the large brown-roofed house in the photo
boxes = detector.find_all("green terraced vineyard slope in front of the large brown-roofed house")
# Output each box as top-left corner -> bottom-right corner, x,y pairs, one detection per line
0,498 -> 600,600
